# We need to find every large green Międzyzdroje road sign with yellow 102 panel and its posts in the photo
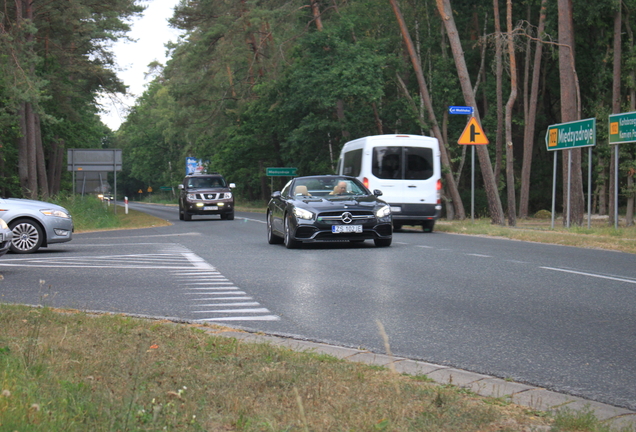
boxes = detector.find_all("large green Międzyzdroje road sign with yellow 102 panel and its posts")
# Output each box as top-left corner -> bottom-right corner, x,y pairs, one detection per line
545,118 -> 596,229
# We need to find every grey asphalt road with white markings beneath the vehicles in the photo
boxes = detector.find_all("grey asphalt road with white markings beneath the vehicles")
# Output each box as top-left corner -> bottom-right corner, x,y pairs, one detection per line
0,204 -> 636,410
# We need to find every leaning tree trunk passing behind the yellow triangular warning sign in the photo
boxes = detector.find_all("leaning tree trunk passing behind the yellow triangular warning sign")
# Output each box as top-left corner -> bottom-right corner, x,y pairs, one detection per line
434,0 -> 505,225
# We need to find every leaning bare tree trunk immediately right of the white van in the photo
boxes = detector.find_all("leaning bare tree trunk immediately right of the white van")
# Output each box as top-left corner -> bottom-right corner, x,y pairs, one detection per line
389,0 -> 466,220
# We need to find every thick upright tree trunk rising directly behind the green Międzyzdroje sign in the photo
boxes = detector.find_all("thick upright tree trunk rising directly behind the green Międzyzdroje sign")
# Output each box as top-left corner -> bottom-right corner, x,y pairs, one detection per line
558,0 -> 584,225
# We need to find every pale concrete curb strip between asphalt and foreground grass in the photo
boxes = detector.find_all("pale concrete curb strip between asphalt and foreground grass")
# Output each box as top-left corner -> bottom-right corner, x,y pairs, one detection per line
206,329 -> 636,432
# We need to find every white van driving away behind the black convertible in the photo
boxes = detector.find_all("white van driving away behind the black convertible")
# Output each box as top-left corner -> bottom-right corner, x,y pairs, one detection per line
337,135 -> 442,231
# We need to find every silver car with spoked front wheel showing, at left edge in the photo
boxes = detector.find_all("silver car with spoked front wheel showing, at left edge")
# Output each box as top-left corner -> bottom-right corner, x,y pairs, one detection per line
0,198 -> 73,254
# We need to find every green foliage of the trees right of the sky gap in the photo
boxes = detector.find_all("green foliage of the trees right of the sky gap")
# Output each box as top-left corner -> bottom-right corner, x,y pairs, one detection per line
108,0 -> 636,215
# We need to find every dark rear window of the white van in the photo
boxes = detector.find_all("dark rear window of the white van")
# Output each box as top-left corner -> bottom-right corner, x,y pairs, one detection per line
371,147 -> 433,180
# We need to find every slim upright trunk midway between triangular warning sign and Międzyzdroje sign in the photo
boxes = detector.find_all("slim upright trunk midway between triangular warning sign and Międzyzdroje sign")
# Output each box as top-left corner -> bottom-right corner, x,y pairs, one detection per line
506,0 -> 517,226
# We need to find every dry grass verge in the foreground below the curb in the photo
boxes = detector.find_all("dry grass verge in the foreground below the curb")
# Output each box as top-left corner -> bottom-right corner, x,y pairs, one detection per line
0,305 -> 580,431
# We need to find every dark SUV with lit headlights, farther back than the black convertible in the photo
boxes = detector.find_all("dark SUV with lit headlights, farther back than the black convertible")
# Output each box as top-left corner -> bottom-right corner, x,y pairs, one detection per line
179,174 -> 236,221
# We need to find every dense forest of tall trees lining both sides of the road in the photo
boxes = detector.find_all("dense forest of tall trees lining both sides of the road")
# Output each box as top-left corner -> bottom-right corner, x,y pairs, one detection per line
0,0 -> 636,225
